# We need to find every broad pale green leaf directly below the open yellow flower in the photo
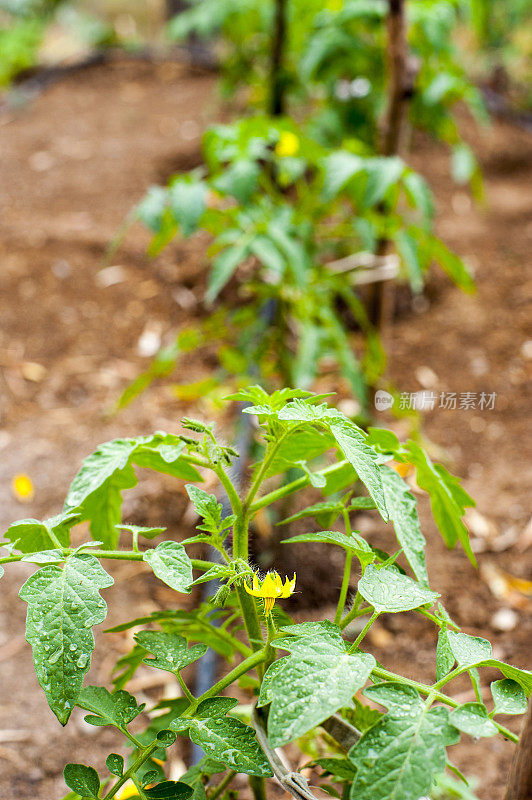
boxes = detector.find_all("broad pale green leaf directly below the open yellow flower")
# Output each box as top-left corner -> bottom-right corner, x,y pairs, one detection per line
263,624 -> 375,747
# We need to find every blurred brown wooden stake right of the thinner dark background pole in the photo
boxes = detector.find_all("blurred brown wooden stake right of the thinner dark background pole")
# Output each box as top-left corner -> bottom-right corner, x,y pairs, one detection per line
370,0 -> 413,334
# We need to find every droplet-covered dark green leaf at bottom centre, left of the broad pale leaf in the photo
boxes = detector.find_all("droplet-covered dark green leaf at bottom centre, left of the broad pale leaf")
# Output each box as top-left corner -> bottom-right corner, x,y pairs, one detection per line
170,697 -> 272,776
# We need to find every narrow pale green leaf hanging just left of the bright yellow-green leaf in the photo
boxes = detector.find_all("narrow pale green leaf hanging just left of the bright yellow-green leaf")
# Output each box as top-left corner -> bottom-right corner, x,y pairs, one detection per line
381,466 -> 429,586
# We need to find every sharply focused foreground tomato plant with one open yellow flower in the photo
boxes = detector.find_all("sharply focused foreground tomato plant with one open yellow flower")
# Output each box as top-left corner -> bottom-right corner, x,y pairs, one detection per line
1,387 -> 532,800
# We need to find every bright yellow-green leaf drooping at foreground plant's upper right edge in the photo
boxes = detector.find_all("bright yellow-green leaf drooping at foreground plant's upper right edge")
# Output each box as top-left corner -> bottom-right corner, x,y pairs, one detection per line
408,441 -> 477,566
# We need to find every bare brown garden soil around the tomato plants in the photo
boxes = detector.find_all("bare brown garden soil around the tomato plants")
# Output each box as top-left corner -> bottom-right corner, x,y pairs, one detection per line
0,63 -> 532,800
